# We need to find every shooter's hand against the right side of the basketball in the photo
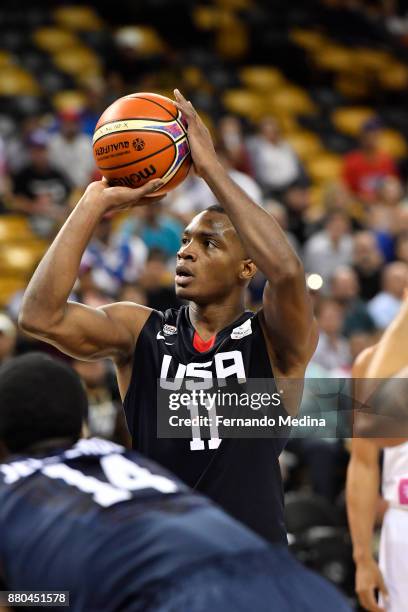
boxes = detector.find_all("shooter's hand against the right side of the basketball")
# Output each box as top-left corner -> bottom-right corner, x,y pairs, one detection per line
174,89 -> 218,176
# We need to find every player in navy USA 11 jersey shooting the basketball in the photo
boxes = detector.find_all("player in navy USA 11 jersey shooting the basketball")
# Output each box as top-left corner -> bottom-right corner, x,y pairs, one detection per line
20,90 -> 317,542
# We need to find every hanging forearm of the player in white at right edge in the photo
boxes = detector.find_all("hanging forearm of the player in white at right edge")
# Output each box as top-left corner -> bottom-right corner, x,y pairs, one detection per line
346,458 -> 379,563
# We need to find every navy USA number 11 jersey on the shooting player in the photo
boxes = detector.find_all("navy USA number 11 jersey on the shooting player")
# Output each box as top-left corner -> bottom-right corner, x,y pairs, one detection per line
124,306 -> 287,543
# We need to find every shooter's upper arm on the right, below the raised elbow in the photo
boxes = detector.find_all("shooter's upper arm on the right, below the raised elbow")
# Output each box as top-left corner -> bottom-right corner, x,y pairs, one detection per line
262,274 -> 318,365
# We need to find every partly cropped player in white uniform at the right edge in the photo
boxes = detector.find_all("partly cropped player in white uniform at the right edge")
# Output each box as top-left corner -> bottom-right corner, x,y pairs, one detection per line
347,301 -> 408,612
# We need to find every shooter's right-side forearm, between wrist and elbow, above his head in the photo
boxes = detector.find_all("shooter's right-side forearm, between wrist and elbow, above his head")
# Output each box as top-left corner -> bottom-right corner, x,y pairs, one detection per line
201,163 -> 303,282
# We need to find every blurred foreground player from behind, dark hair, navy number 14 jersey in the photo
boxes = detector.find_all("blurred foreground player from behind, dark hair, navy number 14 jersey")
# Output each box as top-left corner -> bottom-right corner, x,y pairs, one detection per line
0,353 -> 349,612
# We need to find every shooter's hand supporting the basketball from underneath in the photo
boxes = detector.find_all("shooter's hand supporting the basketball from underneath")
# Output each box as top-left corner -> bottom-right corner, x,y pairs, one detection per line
82,179 -> 164,215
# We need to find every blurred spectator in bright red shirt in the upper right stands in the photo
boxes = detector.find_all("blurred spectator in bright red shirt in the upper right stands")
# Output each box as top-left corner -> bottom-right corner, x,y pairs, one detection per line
343,118 -> 398,204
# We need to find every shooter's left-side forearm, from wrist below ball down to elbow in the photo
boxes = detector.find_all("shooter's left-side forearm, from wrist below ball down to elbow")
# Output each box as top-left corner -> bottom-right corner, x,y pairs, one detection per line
19,196 -> 103,333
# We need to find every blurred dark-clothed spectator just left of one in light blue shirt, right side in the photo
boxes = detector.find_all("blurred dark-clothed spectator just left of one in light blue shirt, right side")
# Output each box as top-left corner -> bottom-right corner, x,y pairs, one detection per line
353,231 -> 384,301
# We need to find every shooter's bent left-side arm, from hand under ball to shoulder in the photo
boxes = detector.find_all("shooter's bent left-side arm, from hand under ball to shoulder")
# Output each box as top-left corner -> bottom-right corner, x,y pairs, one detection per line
19,180 -> 162,361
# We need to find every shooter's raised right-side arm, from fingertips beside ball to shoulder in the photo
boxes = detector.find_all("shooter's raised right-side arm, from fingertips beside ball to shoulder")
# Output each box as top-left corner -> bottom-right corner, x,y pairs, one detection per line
174,90 -> 317,370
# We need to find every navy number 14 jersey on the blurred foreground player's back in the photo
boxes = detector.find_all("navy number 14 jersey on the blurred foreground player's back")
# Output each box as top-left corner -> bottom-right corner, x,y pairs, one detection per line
0,438 -> 267,612
